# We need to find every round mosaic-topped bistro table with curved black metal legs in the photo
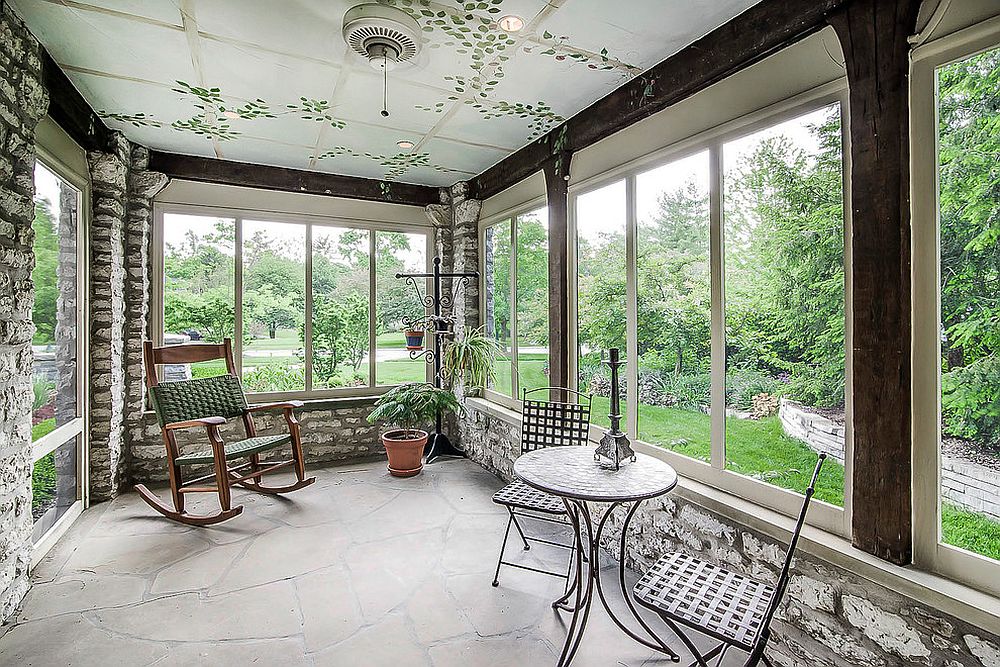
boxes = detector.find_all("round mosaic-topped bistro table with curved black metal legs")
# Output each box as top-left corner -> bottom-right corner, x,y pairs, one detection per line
514,447 -> 680,667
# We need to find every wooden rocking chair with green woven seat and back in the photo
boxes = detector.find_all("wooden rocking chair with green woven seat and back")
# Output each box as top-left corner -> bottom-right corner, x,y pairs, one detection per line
135,338 -> 316,526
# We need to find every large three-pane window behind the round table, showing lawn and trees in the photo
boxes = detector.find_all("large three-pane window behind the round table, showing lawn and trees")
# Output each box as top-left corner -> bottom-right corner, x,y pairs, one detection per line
571,93 -> 850,534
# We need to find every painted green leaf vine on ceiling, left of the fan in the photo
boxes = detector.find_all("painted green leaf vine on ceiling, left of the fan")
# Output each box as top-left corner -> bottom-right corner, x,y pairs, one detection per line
97,81 -> 347,141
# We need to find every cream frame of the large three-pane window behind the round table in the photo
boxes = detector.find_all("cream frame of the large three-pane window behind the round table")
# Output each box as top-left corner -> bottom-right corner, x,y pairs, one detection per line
567,79 -> 854,536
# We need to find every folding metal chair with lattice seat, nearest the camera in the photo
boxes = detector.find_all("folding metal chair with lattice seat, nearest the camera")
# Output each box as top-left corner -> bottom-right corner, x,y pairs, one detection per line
633,454 -> 826,667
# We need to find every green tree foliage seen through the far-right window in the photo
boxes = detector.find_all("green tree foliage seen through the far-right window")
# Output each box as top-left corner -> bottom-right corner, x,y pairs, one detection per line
938,49 -> 1000,452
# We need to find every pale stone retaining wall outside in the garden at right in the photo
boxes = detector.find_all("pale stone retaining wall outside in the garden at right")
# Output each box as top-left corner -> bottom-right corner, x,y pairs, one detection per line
778,399 -> 1000,521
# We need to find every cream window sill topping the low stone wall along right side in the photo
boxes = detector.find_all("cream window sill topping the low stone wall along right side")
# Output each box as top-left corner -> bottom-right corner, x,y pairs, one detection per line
466,398 -> 1000,629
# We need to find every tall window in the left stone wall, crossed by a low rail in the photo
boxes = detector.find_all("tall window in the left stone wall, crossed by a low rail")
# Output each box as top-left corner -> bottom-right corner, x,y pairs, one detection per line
31,160 -> 85,544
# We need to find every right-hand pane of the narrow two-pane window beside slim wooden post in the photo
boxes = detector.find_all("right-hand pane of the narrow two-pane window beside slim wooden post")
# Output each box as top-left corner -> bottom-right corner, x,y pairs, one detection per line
515,207 -> 549,399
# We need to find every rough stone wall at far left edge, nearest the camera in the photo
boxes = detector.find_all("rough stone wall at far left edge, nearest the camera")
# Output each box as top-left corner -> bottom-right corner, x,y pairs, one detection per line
0,3 -> 48,621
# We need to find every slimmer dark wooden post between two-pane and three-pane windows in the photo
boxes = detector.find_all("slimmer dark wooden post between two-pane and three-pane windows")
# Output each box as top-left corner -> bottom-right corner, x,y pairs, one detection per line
543,151 -> 573,400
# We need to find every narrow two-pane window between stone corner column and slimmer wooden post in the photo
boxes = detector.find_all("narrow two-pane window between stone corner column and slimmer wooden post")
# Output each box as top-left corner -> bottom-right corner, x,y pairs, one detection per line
482,207 -> 549,398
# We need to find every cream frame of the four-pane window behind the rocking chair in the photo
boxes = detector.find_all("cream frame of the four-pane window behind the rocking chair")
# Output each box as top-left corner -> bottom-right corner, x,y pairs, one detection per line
150,202 -> 435,401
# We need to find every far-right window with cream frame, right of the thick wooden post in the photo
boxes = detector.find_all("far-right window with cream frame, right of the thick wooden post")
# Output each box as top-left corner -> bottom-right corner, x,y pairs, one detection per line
911,35 -> 1000,595
